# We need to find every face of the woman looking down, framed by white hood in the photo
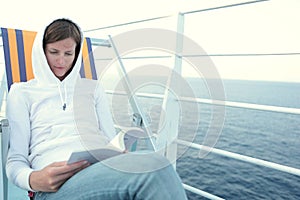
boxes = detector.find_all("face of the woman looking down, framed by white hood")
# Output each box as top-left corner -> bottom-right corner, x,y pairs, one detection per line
45,38 -> 76,81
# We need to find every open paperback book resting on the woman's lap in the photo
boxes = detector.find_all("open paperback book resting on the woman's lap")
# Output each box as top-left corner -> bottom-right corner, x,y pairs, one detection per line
67,128 -> 144,164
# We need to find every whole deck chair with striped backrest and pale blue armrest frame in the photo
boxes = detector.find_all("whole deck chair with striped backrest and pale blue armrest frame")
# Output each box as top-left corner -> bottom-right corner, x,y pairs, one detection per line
0,28 -> 97,200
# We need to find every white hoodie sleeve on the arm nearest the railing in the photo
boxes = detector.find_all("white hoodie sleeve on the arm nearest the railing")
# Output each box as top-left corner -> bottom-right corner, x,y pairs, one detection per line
96,84 -> 116,140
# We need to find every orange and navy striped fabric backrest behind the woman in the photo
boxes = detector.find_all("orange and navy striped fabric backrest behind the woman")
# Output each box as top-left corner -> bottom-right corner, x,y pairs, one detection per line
1,28 -> 97,90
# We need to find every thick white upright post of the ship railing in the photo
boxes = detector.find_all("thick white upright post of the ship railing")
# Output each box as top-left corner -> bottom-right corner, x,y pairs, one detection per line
157,13 -> 184,168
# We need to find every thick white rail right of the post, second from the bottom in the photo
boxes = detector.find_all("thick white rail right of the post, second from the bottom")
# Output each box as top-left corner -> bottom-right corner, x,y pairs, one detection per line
176,139 -> 300,176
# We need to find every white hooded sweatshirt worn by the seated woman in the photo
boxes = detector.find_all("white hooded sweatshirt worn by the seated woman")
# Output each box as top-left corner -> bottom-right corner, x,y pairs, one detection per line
6,25 -> 116,190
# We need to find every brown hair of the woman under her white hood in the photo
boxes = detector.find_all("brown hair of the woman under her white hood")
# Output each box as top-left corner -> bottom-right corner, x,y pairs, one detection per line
43,18 -> 82,65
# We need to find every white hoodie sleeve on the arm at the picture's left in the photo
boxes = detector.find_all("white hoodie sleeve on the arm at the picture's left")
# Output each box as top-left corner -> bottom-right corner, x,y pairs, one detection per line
6,84 -> 33,190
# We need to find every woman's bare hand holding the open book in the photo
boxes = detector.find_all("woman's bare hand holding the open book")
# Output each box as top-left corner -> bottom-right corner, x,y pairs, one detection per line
29,161 -> 90,192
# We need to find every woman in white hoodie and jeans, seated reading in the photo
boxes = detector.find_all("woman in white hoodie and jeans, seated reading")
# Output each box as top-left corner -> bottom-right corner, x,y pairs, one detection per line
6,19 -> 186,199
